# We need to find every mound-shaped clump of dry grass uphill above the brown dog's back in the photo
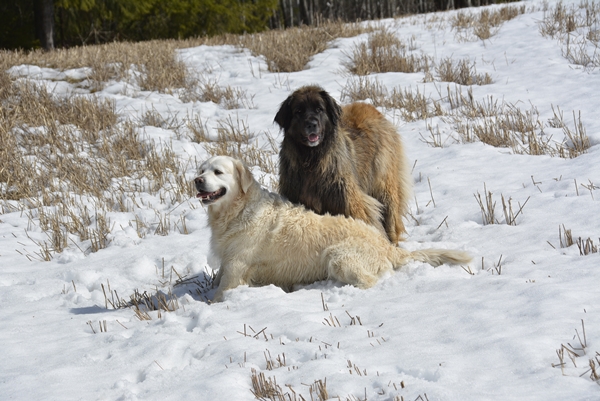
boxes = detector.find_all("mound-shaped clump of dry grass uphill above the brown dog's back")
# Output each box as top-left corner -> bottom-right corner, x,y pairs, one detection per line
344,29 -> 431,75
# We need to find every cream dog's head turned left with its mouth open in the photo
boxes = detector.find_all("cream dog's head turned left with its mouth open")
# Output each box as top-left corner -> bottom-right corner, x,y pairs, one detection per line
194,156 -> 254,206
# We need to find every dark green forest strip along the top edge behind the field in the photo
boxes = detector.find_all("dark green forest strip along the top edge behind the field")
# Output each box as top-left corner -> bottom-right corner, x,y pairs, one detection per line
0,0 -> 505,49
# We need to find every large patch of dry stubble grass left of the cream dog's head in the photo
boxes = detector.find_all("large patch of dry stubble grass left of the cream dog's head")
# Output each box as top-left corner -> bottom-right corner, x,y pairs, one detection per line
0,75 -> 194,260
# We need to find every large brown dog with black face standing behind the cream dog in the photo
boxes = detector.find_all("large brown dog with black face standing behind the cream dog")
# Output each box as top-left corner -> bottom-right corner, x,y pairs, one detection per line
275,86 -> 412,244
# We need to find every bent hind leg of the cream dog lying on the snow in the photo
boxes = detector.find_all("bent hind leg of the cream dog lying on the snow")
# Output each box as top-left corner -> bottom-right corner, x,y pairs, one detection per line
322,243 -> 384,289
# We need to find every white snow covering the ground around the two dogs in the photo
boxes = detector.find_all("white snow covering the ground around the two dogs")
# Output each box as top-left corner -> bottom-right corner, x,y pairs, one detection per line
0,2 -> 600,401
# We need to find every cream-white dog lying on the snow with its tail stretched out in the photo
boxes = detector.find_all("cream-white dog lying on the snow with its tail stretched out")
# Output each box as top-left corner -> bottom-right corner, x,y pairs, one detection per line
194,156 -> 471,301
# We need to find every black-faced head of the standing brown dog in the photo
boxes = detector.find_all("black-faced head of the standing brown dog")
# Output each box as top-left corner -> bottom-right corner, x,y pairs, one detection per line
275,86 -> 342,147
